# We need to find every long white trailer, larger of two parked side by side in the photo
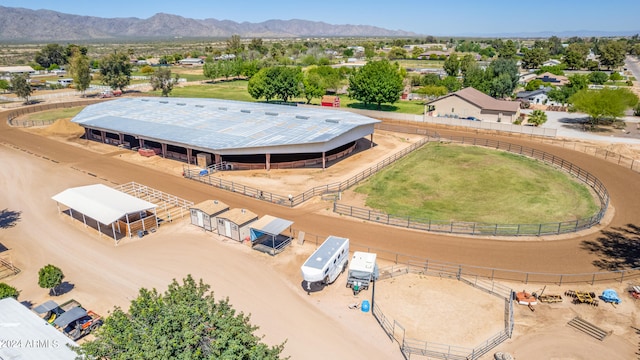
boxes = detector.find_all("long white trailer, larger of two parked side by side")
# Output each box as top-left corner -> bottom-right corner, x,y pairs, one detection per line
300,235 -> 349,290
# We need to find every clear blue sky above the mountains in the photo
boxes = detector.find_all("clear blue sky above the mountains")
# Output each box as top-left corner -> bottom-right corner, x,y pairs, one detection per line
0,0 -> 640,35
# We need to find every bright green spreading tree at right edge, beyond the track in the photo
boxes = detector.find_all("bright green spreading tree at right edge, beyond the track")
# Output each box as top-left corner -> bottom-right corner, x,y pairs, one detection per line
569,89 -> 638,127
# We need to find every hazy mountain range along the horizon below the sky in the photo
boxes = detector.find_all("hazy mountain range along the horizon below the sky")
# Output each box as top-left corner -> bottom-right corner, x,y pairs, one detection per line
0,6 -> 418,42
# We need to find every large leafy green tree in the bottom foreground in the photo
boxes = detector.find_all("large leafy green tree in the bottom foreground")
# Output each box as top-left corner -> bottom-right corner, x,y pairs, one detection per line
78,275 -> 284,360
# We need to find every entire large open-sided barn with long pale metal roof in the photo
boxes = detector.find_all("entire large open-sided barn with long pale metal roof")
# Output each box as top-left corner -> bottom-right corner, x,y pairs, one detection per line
72,98 -> 379,170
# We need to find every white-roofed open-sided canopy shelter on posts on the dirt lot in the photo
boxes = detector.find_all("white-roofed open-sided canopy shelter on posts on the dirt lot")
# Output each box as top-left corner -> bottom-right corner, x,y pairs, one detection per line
52,184 -> 158,245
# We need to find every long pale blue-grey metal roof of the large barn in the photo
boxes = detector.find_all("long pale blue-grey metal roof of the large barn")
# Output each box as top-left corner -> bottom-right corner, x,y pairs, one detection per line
72,98 -> 380,154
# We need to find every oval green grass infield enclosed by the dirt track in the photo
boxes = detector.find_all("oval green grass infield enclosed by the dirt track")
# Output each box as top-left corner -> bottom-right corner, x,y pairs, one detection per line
355,144 -> 598,224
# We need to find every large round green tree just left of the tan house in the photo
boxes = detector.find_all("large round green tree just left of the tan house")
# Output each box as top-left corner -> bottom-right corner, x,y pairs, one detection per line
349,60 -> 404,109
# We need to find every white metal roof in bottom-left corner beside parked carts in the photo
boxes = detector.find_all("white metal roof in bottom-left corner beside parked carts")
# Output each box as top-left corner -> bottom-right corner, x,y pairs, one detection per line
0,298 -> 78,360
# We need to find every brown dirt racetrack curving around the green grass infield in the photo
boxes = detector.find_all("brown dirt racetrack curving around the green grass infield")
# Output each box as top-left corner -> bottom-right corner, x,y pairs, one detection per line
0,104 -> 640,274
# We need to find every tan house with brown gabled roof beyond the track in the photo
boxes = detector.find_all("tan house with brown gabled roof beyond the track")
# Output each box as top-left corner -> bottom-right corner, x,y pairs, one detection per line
427,87 -> 520,123
